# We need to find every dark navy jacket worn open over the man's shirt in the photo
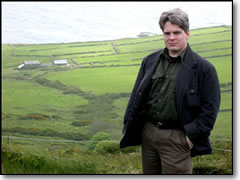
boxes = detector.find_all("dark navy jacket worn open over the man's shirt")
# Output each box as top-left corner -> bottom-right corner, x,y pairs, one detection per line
120,45 -> 220,156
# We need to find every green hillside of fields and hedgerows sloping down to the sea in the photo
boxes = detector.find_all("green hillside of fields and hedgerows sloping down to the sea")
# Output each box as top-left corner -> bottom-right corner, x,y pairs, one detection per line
2,26 -> 232,174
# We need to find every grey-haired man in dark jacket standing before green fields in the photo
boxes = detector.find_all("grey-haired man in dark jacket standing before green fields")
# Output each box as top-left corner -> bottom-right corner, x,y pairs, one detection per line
120,9 -> 220,174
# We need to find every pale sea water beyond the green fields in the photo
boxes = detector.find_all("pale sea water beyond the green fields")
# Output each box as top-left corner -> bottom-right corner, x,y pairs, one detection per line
2,1 -> 232,44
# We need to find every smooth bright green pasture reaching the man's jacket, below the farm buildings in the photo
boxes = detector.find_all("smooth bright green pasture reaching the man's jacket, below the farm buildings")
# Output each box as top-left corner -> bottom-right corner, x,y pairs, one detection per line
46,66 -> 139,95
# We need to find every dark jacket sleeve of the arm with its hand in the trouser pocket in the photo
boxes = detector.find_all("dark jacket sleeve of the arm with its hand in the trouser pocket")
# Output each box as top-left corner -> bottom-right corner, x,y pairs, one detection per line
184,65 -> 220,143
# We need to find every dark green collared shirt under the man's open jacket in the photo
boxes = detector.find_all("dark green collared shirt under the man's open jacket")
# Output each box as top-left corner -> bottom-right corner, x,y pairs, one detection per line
147,48 -> 186,127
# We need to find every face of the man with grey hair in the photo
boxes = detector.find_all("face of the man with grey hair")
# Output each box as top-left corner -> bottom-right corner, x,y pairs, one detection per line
163,21 -> 189,56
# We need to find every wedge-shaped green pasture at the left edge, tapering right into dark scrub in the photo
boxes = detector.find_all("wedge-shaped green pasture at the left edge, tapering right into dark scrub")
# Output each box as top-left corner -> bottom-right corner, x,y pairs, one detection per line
2,79 -> 88,114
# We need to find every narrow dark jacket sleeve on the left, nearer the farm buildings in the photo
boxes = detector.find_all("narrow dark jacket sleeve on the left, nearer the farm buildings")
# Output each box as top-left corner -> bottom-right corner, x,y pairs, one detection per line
123,57 -> 147,134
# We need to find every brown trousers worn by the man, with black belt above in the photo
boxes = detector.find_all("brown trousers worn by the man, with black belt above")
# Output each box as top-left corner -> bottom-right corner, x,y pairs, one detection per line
142,122 -> 192,174
